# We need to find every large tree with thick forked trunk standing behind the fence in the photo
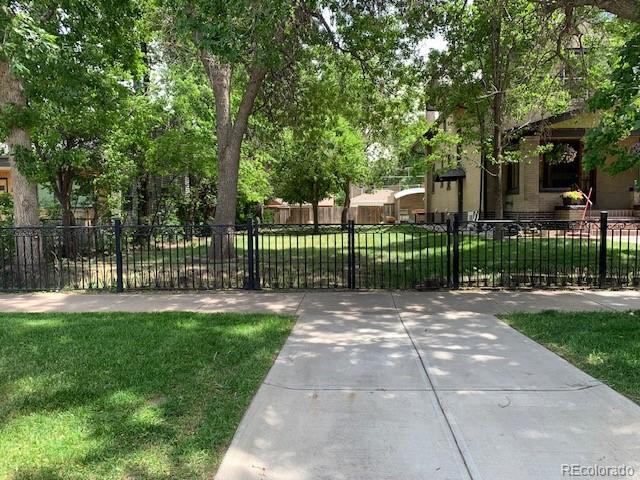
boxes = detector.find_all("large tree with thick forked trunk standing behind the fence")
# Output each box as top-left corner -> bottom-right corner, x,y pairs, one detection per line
161,0 -> 399,252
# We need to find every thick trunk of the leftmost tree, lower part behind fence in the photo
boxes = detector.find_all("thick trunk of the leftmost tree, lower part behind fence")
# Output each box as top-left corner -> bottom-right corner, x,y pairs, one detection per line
0,60 -> 42,288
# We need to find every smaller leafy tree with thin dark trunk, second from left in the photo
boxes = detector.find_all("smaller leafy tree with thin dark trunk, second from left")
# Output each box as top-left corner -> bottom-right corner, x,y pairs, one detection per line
25,61 -> 129,235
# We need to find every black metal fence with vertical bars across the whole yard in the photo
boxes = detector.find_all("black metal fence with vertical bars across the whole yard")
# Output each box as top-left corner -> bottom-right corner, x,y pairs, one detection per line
0,213 -> 640,291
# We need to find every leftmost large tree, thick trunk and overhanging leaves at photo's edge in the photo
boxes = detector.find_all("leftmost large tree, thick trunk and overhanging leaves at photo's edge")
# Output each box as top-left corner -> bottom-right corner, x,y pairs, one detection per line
0,0 -> 139,276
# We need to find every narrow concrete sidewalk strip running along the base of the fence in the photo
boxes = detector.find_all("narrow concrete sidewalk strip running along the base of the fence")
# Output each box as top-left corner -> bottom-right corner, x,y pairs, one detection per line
0,290 -> 640,316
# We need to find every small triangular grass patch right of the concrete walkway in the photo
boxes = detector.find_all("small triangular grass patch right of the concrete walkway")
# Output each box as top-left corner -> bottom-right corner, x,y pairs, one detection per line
502,311 -> 640,404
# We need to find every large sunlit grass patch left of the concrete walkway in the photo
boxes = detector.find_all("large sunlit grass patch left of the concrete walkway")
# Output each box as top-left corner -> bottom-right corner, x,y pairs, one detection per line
0,313 -> 293,480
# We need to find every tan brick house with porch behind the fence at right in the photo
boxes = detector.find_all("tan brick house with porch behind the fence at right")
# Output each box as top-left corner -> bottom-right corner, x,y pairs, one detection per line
425,110 -> 640,219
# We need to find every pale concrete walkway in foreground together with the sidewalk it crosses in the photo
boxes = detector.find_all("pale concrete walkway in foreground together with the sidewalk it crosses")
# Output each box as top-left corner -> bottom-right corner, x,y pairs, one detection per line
0,291 -> 640,480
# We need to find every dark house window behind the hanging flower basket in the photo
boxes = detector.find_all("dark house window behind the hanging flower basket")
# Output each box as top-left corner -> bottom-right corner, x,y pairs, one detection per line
540,140 -> 582,190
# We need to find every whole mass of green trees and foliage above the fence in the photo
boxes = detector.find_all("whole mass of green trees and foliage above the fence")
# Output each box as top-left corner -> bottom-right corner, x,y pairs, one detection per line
0,0 -> 640,242
